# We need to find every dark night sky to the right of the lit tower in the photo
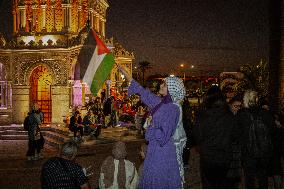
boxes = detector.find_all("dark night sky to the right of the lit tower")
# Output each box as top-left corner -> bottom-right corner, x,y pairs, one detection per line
106,0 -> 269,75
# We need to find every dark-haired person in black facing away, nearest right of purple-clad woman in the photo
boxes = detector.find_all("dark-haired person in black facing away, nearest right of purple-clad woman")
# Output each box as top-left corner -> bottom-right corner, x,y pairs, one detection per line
193,86 -> 235,189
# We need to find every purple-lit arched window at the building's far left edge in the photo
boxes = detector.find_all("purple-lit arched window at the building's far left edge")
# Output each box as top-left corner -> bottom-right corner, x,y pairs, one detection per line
0,63 -> 9,109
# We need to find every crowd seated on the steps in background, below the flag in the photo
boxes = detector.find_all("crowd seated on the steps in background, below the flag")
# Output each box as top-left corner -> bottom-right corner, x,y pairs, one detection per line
67,90 -> 149,141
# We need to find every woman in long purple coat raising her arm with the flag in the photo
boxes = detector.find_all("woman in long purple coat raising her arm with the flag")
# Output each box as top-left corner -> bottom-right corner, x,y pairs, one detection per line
118,66 -> 185,189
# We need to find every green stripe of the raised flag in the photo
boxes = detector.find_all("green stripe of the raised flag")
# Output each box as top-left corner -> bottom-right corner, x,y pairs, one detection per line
91,53 -> 115,96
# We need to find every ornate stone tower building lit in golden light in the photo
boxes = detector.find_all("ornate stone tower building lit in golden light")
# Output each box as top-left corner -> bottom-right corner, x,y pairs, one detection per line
0,0 -> 134,123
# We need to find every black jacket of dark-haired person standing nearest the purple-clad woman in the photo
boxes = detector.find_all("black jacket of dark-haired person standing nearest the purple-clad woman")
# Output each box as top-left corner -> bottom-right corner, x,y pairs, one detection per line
193,105 -> 235,166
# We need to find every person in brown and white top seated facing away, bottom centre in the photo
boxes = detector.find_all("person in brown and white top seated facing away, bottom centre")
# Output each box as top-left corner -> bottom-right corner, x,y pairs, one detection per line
99,141 -> 138,189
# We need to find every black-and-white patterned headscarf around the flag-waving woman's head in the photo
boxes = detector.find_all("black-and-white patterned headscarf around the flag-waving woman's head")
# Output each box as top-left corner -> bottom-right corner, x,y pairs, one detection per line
165,77 -> 185,102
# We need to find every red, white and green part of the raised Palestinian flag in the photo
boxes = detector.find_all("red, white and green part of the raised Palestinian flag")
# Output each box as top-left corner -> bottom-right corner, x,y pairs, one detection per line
83,30 -> 115,96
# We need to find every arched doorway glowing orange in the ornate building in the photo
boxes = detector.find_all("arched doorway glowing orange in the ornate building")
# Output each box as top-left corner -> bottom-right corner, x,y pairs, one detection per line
30,65 -> 52,123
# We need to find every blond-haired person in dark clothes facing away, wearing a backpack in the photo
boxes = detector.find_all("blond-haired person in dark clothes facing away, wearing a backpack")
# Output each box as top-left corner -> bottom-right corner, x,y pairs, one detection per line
236,90 -> 275,189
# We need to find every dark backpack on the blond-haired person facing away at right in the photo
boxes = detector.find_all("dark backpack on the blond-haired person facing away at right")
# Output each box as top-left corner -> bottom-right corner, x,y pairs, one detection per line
247,114 -> 272,158
